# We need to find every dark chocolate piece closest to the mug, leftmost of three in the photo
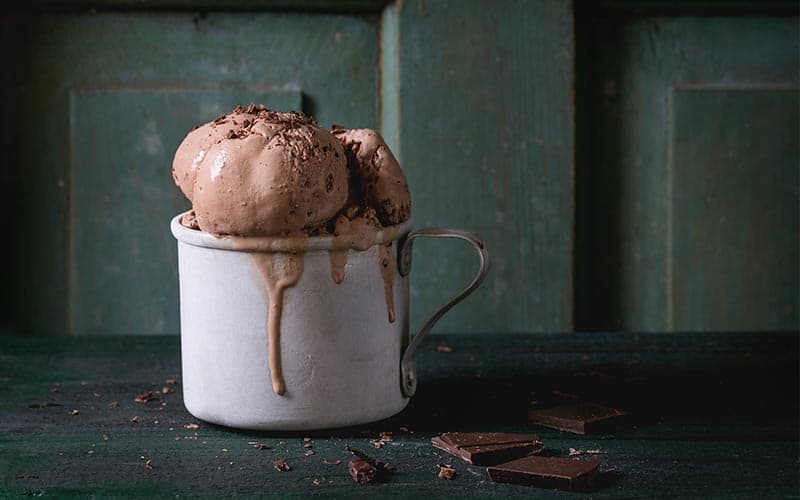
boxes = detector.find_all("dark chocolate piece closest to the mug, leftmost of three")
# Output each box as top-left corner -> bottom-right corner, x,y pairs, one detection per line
431,432 -> 544,465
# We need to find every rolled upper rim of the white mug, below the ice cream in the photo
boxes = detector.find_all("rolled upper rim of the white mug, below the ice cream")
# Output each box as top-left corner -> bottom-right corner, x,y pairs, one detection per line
170,210 -> 412,252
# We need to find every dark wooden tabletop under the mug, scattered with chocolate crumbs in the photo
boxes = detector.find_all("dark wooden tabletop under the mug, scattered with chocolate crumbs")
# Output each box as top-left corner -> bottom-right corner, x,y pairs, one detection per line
0,333 -> 800,498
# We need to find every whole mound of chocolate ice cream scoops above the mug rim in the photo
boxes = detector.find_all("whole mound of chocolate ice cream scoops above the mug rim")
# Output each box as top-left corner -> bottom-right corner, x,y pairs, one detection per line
172,104 -> 411,239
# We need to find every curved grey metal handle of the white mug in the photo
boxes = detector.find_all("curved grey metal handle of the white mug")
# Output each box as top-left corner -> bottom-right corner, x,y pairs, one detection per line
397,227 -> 489,398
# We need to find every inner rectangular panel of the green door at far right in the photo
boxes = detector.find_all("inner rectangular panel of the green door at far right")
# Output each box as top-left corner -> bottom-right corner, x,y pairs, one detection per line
666,87 -> 800,331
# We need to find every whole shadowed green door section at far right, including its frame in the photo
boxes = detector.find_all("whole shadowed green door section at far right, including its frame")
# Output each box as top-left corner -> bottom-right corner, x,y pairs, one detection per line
577,8 -> 800,331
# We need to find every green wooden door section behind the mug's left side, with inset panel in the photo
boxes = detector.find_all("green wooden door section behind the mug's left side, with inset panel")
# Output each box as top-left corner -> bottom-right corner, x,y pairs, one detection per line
0,9 -> 379,334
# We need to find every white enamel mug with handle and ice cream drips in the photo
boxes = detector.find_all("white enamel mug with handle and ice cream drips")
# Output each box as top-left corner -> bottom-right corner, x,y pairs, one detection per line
171,214 -> 489,431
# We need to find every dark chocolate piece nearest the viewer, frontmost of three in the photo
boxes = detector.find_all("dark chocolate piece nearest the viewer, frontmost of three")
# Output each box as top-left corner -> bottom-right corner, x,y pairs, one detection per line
488,456 -> 601,491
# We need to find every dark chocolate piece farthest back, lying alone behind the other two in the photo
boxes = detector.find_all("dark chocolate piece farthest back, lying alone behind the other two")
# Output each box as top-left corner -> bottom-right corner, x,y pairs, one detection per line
528,403 -> 625,434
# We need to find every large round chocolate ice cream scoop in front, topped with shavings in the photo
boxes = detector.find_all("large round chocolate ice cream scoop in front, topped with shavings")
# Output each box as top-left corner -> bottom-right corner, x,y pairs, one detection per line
173,105 -> 349,236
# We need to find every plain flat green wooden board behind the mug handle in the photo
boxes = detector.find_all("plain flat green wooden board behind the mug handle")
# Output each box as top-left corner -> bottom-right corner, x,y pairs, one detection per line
394,0 -> 575,332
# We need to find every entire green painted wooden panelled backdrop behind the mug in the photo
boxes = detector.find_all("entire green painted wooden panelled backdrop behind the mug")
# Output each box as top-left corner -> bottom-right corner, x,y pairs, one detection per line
0,0 -> 800,335
